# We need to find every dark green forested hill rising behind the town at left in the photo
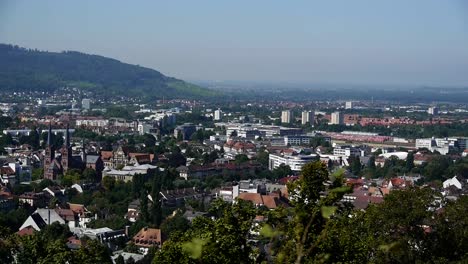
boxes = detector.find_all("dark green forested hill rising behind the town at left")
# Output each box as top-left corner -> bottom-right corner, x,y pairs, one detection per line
0,44 -> 216,98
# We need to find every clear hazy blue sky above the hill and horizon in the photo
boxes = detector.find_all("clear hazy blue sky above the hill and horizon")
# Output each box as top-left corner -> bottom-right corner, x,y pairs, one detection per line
0,0 -> 468,87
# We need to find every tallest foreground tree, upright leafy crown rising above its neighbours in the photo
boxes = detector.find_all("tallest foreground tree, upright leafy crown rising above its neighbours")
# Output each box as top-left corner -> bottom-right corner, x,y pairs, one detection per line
278,161 -> 350,263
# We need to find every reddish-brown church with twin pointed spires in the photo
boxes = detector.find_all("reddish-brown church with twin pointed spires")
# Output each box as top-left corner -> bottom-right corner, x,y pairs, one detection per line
44,124 -> 104,180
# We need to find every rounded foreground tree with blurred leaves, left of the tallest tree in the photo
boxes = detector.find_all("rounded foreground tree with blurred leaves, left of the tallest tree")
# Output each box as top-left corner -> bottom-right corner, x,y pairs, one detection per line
153,200 -> 258,263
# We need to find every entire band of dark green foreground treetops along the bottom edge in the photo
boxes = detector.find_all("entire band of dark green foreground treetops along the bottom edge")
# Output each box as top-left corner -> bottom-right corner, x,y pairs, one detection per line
153,162 -> 468,263
